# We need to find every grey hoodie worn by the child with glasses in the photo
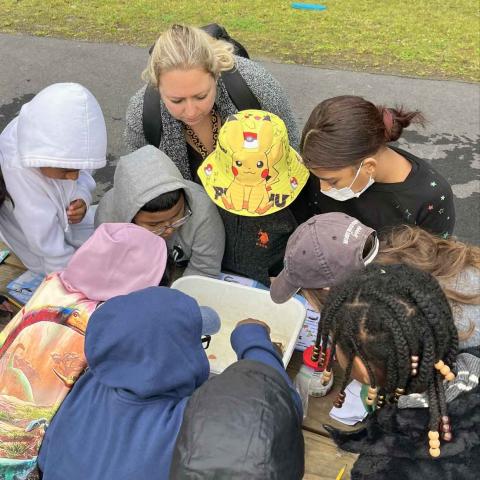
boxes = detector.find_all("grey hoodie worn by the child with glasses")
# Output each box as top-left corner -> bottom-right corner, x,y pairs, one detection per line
95,145 -> 225,277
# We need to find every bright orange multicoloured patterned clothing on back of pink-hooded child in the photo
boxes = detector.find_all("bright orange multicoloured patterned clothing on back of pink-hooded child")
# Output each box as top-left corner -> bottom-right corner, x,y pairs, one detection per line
0,274 -> 98,480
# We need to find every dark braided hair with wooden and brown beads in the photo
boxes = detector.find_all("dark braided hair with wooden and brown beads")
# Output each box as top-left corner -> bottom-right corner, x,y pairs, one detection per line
316,265 -> 458,457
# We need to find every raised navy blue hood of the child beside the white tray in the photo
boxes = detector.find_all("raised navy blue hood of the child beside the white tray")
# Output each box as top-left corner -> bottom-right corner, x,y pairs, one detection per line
85,287 -> 209,399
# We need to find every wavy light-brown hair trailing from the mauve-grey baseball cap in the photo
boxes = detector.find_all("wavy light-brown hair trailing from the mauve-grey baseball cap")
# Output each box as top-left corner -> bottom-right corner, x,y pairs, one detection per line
375,225 -> 480,339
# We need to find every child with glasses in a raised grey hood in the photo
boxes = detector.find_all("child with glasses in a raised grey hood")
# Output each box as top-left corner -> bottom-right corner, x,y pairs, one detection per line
95,146 -> 225,277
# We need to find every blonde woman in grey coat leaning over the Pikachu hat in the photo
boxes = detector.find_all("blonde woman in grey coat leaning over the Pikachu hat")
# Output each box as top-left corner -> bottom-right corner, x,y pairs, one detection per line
125,25 -> 299,182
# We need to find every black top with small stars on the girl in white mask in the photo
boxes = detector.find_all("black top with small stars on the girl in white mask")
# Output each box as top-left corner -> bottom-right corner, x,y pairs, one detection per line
305,146 -> 455,238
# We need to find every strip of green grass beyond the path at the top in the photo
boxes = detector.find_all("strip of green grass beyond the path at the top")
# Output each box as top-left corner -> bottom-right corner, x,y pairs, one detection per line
0,0 -> 480,81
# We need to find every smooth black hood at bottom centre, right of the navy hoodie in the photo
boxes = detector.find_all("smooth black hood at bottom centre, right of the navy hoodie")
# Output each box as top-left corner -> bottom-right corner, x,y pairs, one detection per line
170,360 -> 304,480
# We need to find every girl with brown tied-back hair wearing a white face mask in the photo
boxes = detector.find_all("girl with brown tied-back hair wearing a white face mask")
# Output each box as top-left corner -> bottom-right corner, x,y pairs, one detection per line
300,95 -> 455,237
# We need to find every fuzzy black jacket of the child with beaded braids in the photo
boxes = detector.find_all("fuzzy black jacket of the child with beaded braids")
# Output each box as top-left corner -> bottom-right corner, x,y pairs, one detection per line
325,368 -> 480,480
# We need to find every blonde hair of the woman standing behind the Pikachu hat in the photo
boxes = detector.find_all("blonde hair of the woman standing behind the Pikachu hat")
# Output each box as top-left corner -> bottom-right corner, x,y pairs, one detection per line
142,25 -> 235,86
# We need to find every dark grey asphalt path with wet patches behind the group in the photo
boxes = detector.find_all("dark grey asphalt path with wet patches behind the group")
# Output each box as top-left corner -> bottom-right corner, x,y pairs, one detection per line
0,34 -> 480,244
